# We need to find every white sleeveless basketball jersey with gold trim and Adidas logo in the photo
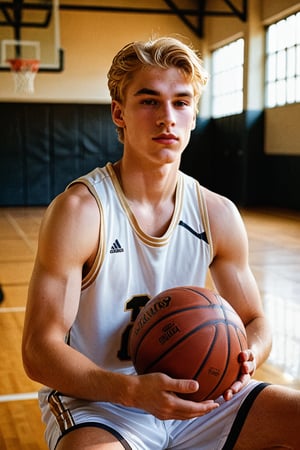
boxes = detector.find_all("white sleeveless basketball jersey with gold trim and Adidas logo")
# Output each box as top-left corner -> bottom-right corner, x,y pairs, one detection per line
68,163 -> 212,373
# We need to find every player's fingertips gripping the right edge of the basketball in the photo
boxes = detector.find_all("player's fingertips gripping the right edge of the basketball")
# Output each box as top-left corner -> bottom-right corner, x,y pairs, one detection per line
223,349 -> 256,401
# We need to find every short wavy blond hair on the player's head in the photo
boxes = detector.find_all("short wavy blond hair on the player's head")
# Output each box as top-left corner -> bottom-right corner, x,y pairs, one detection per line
107,37 -> 208,142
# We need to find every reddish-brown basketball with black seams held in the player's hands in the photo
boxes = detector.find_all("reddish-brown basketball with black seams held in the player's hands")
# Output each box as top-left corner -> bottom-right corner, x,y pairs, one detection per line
129,286 -> 247,402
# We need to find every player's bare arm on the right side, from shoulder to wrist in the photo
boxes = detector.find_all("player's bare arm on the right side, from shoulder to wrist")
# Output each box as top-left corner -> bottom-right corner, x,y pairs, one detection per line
207,193 -> 271,384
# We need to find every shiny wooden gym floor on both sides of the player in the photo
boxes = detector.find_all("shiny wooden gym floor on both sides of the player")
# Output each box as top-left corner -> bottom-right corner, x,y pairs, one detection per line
0,207 -> 300,450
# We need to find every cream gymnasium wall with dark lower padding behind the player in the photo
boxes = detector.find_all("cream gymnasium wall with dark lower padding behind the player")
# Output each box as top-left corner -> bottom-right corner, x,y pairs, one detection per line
0,0 -> 300,209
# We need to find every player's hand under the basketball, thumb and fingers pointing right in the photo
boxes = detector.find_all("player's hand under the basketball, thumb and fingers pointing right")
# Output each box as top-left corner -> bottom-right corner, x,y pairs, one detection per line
133,373 -> 219,420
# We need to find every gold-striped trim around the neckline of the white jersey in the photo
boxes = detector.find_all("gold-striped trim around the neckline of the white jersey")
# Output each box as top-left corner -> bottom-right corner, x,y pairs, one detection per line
106,163 -> 183,247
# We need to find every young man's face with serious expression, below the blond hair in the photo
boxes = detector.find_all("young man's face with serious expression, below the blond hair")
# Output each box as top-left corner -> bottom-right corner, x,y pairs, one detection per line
113,67 -> 195,164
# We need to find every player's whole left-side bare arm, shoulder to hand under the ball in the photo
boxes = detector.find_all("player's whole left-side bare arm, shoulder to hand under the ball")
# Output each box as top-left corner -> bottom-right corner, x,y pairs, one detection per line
22,185 -> 218,419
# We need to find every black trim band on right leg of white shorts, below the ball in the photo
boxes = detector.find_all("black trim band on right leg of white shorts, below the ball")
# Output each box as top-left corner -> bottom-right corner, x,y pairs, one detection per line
222,383 -> 270,450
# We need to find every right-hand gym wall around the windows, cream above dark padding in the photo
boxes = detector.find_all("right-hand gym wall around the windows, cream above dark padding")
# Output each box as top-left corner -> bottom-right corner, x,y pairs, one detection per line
203,0 -> 300,209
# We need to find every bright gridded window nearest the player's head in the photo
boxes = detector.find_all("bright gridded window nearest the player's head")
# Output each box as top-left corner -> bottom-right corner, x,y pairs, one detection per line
212,39 -> 244,118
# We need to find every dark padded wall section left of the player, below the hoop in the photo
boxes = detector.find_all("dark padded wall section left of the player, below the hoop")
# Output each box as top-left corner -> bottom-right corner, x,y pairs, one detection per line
0,103 -> 122,206
